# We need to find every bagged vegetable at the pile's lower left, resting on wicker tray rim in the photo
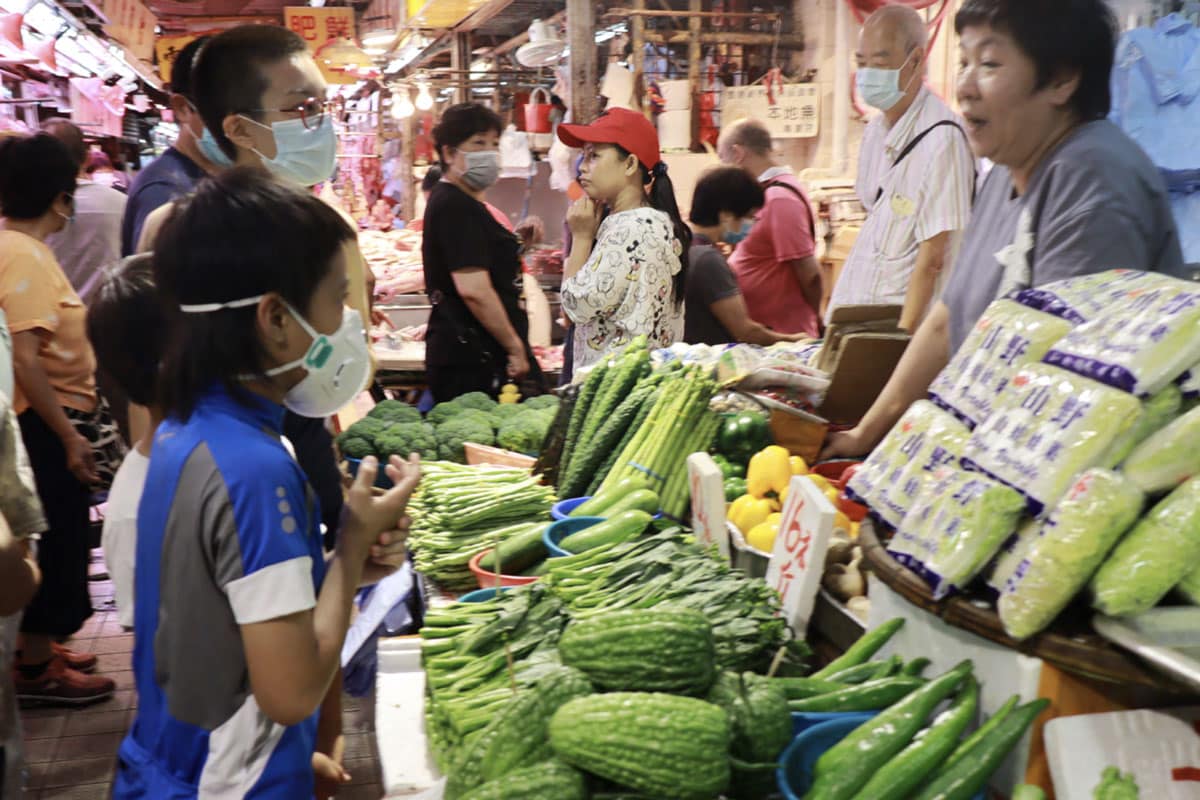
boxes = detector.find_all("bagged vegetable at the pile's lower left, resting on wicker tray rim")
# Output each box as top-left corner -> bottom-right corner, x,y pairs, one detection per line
888,467 -> 1025,599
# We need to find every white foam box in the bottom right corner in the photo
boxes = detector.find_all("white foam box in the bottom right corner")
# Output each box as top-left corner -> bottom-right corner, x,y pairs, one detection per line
1045,706 -> 1200,800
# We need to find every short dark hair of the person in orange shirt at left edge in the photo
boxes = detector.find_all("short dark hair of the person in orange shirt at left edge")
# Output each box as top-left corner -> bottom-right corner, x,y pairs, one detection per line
0,133 -> 79,219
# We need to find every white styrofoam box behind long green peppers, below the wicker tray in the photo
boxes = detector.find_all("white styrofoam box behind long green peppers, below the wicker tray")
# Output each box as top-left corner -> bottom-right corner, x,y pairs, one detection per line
866,575 -> 1046,798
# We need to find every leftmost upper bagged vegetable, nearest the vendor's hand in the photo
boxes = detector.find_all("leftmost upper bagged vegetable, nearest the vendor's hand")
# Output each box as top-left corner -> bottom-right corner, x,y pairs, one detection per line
846,401 -> 971,528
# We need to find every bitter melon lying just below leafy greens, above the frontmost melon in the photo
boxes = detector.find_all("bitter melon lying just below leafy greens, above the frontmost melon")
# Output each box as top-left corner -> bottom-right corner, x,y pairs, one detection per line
558,608 -> 716,694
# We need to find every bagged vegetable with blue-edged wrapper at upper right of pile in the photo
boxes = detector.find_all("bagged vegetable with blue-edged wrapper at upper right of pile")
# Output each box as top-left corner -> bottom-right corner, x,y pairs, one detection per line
1043,277 -> 1200,397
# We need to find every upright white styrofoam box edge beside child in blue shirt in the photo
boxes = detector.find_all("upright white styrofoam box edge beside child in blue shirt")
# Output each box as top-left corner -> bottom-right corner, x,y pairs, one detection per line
376,636 -> 443,800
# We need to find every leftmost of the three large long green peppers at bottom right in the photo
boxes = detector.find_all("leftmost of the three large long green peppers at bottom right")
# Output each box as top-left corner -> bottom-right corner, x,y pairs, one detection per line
804,661 -> 971,800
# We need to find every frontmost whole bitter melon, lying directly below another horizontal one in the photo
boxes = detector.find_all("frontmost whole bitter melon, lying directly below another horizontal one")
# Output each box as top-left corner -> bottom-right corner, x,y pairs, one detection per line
550,692 -> 730,800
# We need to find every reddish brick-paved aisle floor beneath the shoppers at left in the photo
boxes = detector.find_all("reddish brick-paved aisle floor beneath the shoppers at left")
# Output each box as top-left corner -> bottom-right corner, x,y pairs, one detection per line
22,551 -> 383,800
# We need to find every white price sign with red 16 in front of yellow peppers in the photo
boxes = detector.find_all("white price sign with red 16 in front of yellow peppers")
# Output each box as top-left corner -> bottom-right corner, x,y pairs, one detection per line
767,475 -> 838,636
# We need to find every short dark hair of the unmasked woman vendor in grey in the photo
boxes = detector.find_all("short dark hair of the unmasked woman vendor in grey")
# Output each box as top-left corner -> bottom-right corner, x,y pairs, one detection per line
954,0 -> 1117,121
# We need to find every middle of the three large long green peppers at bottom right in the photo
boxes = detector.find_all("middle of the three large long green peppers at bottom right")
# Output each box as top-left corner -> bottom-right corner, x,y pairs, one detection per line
854,675 -> 979,800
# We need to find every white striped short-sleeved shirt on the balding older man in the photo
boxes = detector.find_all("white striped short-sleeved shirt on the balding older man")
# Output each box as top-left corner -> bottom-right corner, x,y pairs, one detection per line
829,88 -> 976,314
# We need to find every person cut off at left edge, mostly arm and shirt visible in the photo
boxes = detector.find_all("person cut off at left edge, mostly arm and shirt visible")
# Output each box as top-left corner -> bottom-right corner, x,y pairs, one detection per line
0,304 -> 46,798
